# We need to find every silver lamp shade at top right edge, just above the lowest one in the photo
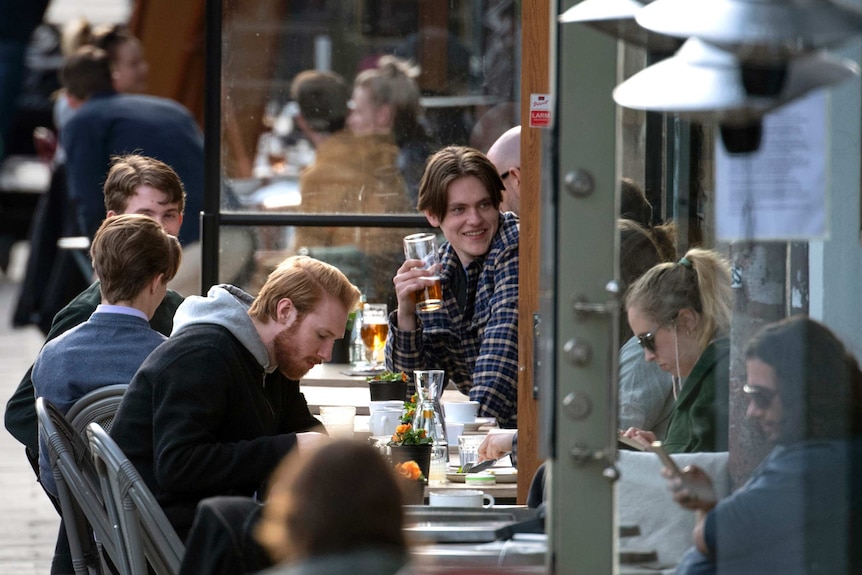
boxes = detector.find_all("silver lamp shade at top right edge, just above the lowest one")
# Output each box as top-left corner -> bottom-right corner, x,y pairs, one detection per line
635,0 -> 862,62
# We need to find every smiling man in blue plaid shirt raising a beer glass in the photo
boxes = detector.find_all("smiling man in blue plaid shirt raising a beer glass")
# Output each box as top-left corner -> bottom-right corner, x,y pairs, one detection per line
386,146 -> 518,427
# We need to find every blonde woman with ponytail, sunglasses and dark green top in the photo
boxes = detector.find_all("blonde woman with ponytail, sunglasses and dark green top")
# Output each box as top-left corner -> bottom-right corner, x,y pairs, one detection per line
625,248 -> 732,453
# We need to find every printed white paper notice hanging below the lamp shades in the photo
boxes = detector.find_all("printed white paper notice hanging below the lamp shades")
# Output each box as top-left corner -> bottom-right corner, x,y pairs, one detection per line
715,90 -> 828,241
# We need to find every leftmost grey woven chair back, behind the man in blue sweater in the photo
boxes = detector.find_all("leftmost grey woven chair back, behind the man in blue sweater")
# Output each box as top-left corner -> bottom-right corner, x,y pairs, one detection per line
36,397 -> 127,575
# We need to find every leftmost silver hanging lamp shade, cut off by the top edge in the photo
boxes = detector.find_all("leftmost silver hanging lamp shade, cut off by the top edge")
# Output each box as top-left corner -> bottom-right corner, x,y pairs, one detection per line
558,0 -> 682,53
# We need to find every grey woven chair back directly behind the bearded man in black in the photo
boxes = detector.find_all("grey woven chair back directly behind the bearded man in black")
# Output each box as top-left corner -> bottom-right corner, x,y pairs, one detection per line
87,423 -> 185,575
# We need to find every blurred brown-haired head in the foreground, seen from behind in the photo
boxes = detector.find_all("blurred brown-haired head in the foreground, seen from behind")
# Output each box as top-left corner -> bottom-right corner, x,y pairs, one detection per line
257,440 -> 407,562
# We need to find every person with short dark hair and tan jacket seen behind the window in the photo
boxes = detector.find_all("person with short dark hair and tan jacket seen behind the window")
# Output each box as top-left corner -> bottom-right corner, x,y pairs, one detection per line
291,70 -> 414,302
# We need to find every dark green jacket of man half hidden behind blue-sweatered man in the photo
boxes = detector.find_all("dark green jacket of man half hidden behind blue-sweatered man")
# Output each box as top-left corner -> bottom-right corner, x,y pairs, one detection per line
5,281 -> 183,459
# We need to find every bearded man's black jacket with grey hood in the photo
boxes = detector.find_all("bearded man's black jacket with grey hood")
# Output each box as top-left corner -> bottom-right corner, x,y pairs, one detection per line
111,286 -> 320,538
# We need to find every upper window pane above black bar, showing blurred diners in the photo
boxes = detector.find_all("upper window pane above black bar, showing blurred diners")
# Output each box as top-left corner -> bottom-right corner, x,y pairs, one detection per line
221,0 -> 520,215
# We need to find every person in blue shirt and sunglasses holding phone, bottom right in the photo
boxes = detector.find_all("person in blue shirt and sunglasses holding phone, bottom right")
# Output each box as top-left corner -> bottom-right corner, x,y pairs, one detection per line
662,316 -> 862,575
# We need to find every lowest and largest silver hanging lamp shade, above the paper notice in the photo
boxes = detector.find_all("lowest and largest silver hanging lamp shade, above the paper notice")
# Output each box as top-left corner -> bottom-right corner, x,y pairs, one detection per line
613,38 -> 859,126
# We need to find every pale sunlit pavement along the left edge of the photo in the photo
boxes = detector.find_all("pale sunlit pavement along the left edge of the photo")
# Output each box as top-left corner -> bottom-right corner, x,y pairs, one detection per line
0,245 -> 60,575
